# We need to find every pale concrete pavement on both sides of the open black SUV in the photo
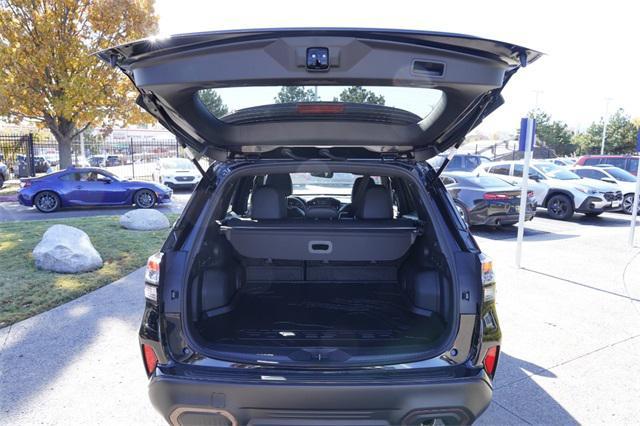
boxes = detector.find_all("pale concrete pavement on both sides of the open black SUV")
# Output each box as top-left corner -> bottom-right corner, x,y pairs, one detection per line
0,213 -> 640,425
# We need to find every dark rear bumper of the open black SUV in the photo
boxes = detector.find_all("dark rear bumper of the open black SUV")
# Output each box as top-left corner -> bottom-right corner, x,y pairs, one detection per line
149,372 -> 492,426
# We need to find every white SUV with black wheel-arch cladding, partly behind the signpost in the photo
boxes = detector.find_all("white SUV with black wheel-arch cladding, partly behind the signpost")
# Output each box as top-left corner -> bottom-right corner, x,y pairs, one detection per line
478,160 -> 622,220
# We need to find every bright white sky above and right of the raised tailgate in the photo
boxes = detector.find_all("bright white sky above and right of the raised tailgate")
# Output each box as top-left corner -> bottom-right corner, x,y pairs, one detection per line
156,0 -> 640,133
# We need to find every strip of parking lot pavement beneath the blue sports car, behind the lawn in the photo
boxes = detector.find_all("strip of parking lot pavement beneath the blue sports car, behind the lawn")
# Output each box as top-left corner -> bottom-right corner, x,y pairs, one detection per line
0,191 -> 191,222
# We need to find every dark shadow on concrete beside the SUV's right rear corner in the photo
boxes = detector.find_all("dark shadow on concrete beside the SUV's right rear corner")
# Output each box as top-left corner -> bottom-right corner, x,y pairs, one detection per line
475,352 -> 578,425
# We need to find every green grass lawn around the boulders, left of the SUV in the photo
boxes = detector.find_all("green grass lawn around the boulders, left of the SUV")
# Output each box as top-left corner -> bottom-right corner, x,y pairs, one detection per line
0,214 -> 178,327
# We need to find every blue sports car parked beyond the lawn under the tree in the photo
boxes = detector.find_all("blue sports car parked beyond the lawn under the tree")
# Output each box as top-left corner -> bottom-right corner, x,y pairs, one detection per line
18,168 -> 173,213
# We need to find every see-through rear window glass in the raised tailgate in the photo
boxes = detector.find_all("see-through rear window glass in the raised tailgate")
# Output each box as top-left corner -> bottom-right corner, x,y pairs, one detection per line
198,86 -> 444,121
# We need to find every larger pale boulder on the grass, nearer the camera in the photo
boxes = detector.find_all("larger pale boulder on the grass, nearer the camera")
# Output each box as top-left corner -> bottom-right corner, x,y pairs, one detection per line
33,225 -> 102,274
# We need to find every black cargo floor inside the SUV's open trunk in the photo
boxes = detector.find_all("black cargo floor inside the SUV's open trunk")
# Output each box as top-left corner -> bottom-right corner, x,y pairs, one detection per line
198,283 -> 444,353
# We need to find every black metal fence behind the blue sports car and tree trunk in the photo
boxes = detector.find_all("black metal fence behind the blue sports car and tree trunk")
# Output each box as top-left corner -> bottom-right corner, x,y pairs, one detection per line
0,133 -> 199,179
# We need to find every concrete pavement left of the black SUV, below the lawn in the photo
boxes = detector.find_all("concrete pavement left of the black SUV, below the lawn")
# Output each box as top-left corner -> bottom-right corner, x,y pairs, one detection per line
0,269 -> 164,425
